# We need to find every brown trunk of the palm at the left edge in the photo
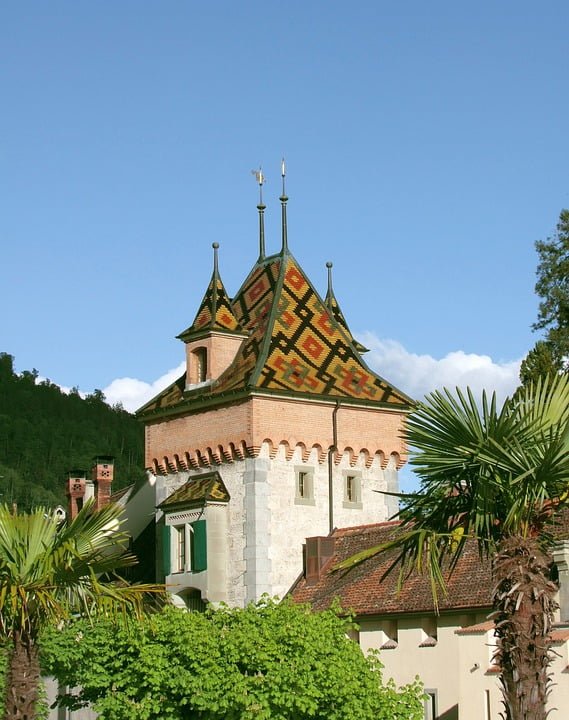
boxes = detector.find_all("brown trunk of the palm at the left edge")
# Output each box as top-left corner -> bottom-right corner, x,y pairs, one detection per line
4,637 -> 40,720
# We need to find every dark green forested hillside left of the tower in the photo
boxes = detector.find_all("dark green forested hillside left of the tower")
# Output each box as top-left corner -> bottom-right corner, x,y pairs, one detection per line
0,353 -> 144,510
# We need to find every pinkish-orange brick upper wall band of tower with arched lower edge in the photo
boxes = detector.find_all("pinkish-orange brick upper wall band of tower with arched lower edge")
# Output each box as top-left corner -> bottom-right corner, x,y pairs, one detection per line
145,396 -> 406,470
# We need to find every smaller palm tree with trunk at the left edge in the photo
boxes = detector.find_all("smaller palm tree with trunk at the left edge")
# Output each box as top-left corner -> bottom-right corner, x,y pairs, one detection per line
0,503 -> 159,720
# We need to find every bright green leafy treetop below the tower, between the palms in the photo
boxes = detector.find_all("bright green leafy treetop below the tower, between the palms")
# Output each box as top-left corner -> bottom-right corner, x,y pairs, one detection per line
42,600 -> 423,720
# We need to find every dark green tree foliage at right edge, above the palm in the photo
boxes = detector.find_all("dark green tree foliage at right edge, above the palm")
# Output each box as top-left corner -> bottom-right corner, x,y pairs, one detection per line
534,210 -> 569,365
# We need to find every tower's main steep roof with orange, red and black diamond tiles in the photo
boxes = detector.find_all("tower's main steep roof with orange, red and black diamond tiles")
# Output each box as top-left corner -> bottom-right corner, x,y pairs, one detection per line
139,251 -> 413,415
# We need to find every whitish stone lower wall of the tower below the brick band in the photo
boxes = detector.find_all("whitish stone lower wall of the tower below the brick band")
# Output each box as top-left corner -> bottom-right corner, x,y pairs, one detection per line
153,443 -> 398,606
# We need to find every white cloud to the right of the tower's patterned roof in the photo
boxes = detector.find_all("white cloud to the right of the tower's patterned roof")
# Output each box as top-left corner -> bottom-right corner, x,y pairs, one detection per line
361,332 -> 521,400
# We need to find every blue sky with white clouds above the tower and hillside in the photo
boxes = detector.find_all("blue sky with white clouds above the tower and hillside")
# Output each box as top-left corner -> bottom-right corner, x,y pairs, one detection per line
0,0 -> 569,420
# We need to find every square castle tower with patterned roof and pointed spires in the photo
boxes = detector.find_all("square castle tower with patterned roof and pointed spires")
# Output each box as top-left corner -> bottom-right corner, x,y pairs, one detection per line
138,163 -> 412,605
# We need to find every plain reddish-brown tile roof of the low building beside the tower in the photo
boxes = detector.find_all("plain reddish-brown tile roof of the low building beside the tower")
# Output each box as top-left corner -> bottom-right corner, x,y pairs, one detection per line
290,511 -> 569,615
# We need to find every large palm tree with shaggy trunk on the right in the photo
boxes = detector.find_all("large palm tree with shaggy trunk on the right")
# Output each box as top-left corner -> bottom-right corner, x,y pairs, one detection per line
340,376 -> 569,720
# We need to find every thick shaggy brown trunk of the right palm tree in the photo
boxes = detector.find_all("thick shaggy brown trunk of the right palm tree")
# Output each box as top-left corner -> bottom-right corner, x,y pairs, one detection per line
491,537 -> 557,720
